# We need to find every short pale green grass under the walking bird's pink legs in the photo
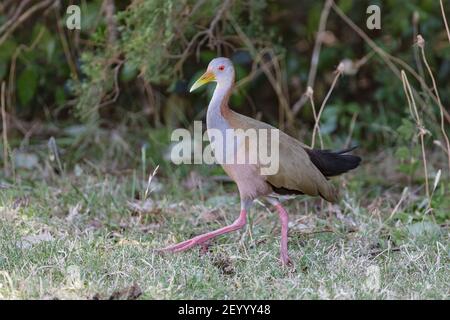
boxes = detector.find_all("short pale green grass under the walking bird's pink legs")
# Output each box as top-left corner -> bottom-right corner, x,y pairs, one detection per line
0,133 -> 450,299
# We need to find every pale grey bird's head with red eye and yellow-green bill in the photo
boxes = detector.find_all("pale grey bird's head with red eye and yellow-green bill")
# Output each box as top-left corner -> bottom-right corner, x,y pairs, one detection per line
190,58 -> 234,92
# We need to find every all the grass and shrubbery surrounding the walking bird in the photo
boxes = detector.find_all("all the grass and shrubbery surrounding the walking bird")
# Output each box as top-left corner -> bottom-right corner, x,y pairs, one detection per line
0,0 -> 450,298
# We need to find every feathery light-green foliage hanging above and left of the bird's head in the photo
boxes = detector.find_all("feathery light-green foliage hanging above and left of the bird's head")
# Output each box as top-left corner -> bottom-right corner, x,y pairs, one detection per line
71,0 -> 269,119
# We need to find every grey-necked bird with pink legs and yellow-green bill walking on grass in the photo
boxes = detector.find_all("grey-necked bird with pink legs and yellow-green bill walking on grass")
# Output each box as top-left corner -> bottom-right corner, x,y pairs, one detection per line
159,57 -> 361,266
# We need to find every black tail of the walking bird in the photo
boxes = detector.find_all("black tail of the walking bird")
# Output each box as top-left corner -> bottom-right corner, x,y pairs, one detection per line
305,147 -> 361,177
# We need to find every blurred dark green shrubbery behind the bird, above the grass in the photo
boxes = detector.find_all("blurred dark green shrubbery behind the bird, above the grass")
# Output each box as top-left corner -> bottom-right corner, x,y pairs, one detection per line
0,0 -> 450,178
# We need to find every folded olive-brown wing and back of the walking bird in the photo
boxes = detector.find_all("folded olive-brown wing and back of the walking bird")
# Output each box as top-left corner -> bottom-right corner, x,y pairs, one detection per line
223,109 -> 337,202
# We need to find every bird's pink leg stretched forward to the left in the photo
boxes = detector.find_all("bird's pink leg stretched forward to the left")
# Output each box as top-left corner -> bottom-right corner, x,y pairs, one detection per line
159,208 -> 247,252
